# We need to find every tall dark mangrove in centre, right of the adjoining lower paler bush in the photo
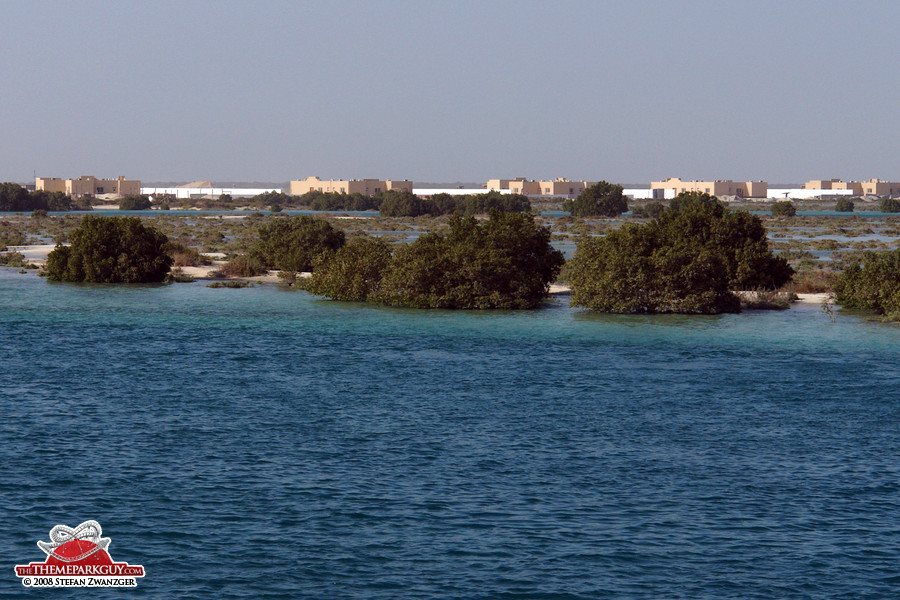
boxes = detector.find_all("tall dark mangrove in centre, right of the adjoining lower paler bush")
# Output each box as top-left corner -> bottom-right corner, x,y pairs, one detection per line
374,212 -> 564,309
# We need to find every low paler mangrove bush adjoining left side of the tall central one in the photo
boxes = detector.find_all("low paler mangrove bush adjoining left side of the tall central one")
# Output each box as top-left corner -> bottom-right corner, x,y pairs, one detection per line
304,237 -> 391,302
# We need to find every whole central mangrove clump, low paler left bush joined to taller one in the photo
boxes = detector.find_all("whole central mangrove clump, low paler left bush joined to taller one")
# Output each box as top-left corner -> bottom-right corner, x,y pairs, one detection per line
307,211 -> 564,309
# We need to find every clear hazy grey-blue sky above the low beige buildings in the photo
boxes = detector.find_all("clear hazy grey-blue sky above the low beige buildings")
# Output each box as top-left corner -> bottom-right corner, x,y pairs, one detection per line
0,0 -> 900,183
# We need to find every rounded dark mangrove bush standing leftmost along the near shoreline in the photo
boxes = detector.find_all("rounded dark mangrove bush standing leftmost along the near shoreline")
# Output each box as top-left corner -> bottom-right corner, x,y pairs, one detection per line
46,216 -> 172,283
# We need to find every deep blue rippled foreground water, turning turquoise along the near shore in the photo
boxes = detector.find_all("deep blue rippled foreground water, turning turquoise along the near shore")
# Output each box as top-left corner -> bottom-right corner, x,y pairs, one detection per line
0,270 -> 900,599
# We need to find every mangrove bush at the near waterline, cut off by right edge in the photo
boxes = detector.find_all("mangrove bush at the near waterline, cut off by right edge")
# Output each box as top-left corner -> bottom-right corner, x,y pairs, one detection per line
834,249 -> 900,321
